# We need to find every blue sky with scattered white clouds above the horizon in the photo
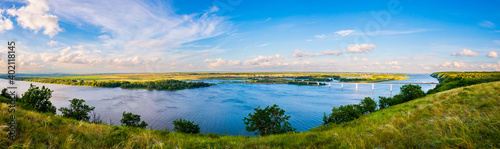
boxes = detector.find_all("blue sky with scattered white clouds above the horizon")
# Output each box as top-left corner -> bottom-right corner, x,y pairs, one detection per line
0,0 -> 500,73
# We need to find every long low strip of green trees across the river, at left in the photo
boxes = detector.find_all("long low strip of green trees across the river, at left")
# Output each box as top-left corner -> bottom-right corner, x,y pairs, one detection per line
22,78 -> 213,90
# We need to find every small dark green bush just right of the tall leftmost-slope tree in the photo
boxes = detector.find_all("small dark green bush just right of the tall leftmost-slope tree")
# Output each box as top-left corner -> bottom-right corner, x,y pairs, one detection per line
59,98 -> 95,122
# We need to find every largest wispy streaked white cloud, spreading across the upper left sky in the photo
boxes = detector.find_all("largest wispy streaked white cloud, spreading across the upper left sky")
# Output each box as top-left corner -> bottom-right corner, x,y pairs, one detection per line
49,0 -> 232,49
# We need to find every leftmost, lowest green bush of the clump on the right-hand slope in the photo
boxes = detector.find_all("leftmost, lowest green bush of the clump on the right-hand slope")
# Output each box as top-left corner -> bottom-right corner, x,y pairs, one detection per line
323,105 -> 361,126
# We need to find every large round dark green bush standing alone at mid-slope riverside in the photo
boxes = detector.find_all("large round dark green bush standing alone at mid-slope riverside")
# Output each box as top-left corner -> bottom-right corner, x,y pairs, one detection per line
243,104 -> 296,136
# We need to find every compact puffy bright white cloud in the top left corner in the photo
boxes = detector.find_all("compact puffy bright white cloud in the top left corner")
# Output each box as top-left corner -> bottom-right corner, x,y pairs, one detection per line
7,0 -> 62,38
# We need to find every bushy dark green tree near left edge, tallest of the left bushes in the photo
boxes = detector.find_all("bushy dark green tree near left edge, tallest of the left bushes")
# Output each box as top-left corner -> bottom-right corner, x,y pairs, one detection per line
20,84 -> 56,114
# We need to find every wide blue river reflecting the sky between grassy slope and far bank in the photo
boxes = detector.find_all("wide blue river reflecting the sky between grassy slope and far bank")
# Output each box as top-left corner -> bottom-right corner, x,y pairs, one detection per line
0,75 -> 438,136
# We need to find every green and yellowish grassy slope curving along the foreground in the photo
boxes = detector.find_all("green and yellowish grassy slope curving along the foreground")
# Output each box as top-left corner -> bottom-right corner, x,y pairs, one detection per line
0,82 -> 500,148
